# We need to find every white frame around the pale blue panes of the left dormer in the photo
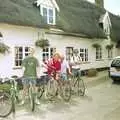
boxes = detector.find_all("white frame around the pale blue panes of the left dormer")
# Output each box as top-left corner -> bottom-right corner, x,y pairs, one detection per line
40,5 -> 56,25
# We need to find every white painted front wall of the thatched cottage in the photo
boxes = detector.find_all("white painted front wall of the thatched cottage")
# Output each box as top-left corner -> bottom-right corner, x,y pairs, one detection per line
0,24 -> 117,77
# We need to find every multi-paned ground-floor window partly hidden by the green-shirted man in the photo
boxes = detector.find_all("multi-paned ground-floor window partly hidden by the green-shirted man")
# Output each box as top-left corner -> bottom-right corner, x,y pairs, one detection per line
14,47 -> 30,67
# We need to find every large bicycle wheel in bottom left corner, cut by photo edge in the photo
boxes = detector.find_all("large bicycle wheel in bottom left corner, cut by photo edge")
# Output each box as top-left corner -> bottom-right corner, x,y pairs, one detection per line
0,92 -> 13,117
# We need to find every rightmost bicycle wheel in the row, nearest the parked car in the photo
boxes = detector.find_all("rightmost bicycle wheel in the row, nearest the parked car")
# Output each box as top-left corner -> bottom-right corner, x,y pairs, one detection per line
74,78 -> 85,96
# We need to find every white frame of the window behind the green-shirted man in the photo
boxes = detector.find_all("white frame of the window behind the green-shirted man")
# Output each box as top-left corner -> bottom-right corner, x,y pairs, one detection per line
14,46 -> 30,68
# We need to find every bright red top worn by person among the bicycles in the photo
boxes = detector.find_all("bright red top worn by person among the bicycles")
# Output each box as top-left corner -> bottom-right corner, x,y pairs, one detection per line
45,58 -> 61,75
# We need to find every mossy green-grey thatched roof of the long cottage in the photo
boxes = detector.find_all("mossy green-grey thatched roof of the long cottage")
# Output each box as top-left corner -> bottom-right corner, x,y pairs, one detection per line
0,0 -> 120,39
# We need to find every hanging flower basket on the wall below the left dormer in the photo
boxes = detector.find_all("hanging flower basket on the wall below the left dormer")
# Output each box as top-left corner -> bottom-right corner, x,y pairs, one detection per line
35,39 -> 50,48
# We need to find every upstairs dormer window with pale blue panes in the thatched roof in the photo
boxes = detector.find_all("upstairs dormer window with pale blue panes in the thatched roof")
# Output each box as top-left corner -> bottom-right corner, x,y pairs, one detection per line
41,7 -> 55,24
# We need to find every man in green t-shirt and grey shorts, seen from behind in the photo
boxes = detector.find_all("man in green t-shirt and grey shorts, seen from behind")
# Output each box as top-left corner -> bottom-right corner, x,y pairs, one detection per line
21,48 -> 40,104
